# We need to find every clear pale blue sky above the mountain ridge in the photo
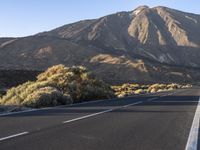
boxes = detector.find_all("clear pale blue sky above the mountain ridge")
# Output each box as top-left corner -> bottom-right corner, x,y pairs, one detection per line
0,0 -> 200,37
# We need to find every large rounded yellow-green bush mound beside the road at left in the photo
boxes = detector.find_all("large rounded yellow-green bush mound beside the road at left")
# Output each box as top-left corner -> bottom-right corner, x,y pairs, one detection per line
0,65 -> 114,107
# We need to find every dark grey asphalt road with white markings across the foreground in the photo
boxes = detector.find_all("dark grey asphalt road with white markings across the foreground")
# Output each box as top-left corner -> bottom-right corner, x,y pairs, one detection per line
0,88 -> 200,150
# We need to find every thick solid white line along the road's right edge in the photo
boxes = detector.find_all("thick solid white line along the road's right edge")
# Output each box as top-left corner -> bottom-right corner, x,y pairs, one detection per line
185,97 -> 200,150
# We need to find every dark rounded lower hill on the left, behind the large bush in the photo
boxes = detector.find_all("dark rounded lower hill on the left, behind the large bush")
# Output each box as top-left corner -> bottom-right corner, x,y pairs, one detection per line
0,36 -> 96,70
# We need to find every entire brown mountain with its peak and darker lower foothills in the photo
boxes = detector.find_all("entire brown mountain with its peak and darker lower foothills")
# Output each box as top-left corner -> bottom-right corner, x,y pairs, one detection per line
0,6 -> 200,83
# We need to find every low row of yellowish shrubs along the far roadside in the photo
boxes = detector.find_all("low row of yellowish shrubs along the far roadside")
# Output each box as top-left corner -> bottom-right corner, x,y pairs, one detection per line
112,83 -> 192,97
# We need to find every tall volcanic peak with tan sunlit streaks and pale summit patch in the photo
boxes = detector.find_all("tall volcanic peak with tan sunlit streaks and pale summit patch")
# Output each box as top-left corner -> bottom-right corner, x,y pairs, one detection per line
40,6 -> 200,67
